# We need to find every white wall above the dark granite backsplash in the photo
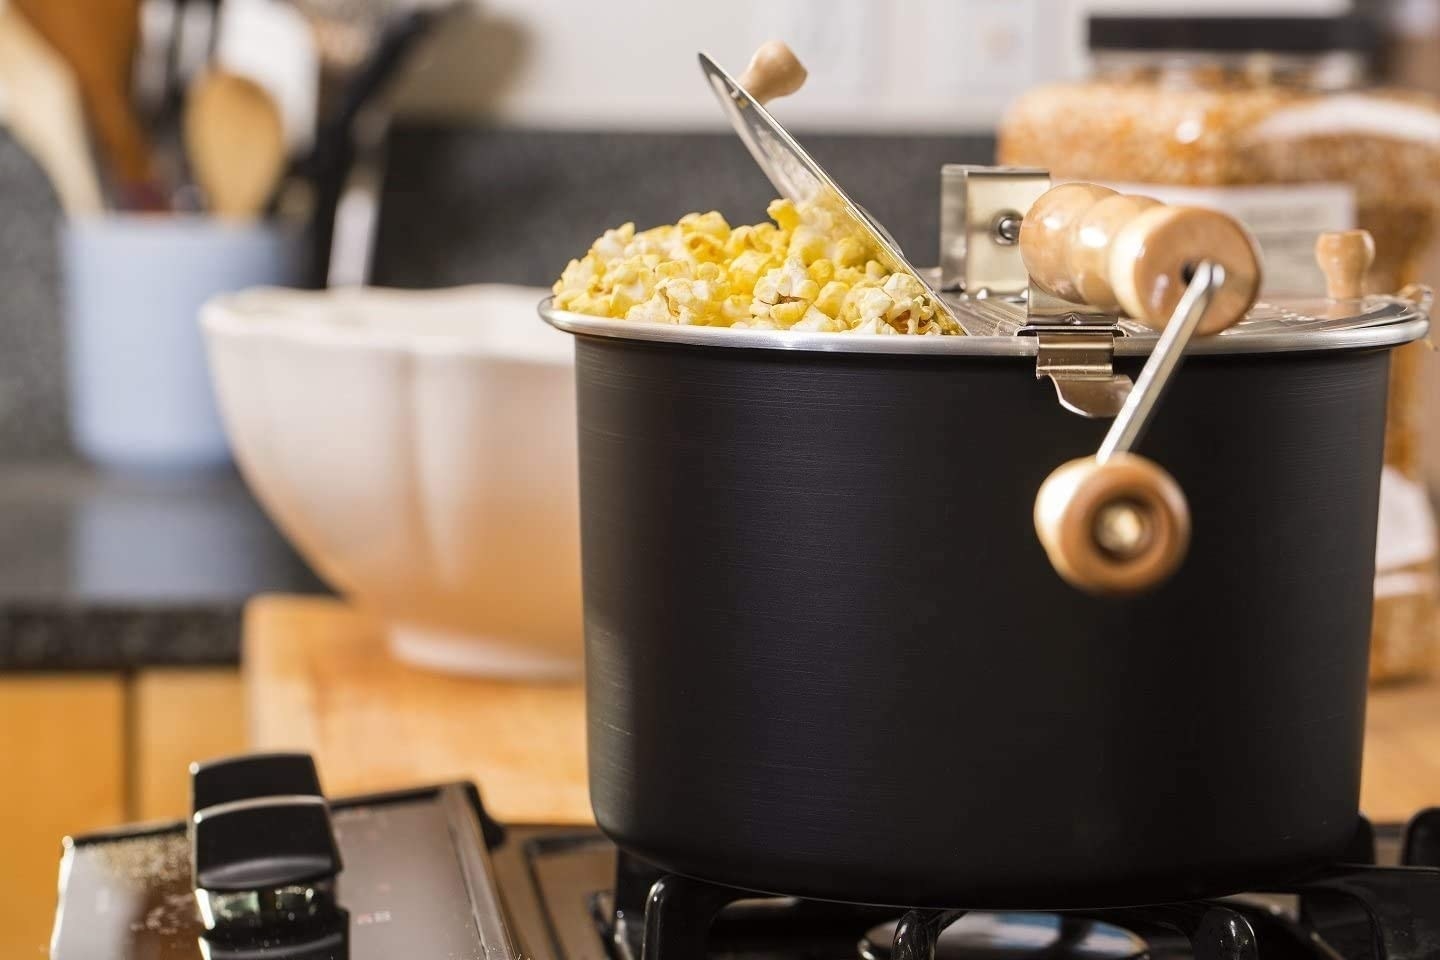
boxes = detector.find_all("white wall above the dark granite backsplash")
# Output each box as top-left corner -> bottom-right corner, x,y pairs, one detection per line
403,0 -> 1349,131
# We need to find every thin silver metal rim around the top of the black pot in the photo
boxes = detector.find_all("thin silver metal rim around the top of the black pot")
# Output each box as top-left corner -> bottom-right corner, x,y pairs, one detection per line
539,296 -> 1430,357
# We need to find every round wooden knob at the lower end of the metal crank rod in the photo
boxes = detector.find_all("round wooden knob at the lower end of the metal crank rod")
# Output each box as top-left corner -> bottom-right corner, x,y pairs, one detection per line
1035,453 -> 1189,594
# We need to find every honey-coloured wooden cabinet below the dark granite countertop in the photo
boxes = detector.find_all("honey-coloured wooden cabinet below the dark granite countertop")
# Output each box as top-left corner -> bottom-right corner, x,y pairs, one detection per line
0,669 -> 245,959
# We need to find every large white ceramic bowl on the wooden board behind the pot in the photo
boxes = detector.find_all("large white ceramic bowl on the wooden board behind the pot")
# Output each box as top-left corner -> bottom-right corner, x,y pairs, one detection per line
202,285 -> 580,679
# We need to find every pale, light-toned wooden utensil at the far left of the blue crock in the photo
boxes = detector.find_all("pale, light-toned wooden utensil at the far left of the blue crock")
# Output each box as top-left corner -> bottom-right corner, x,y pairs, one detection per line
0,6 -> 104,216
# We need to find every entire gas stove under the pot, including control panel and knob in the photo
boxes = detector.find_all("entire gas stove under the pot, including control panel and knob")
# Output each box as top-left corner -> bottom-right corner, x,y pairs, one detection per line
50,754 -> 1440,960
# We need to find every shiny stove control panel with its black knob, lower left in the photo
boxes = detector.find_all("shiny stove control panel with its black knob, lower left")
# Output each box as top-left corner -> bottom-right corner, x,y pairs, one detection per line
50,754 -> 518,960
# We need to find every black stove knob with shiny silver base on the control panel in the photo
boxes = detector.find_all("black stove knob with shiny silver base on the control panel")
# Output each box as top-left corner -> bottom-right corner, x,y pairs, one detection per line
190,754 -> 343,944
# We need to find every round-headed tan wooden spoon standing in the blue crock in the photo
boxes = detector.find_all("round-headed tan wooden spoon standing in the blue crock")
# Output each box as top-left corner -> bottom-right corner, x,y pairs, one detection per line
184,71 -> 285,219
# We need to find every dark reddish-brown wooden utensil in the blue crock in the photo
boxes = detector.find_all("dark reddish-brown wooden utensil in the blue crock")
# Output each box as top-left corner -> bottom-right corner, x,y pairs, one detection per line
10,0 -> 151,186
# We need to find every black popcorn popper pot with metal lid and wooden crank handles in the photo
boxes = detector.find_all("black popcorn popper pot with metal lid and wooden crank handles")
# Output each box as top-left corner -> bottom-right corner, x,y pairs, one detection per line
541,43 -> 1428,908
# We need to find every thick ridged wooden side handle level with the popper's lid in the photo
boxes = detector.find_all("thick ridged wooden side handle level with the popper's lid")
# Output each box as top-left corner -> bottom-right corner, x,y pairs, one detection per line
1020,183 -> 1260,334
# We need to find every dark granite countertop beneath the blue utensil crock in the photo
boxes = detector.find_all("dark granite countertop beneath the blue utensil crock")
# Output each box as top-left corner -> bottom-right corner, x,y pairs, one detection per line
0,461 -> 324,671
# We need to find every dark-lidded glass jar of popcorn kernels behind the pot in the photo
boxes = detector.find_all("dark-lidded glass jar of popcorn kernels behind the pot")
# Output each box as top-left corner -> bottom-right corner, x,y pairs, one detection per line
998,16 -> 1440,687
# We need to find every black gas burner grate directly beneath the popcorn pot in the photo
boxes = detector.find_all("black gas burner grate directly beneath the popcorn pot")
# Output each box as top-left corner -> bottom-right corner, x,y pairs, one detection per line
570,807 -> 1440,960
